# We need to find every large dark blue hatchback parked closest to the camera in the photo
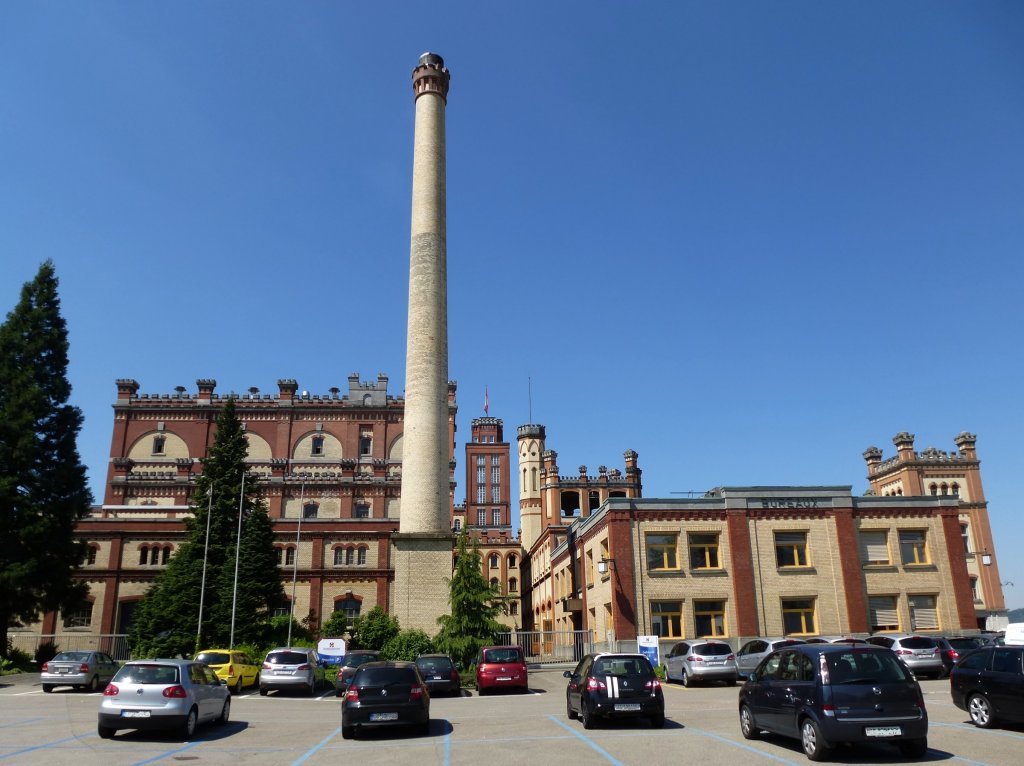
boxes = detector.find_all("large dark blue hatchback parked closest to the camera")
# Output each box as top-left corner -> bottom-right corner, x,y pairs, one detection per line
739,644 -> 928,761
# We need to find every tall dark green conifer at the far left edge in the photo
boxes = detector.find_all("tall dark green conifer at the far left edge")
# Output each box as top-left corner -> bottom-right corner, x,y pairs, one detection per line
0,261 -> 92,652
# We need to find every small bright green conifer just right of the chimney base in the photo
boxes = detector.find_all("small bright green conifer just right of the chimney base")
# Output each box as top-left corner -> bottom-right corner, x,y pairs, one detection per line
434,529 -> 507,668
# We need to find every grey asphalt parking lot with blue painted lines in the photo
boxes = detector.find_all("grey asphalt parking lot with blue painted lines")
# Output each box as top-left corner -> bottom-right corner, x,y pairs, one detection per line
0,668 -> 1024,766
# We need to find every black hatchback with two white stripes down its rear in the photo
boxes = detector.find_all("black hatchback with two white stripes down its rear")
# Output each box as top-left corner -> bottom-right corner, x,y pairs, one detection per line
562,653 -> 665,729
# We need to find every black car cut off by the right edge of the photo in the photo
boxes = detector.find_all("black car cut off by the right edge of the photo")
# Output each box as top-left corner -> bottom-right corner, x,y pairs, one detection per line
949,644 -> 1024,729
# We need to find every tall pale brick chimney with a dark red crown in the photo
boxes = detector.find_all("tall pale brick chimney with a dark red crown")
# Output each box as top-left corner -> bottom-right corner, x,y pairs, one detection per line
392,53 -> 452,634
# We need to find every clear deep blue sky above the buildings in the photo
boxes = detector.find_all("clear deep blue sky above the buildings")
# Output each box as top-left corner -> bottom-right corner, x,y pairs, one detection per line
0,0 -> 1024,607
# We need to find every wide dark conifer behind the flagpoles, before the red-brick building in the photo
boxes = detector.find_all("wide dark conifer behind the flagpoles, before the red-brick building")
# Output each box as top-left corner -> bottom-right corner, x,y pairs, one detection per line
129,398 -> 284,656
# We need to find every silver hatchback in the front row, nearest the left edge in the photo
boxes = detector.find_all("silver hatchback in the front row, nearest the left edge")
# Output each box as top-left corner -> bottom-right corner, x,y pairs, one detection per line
96,659 -> 231,740
